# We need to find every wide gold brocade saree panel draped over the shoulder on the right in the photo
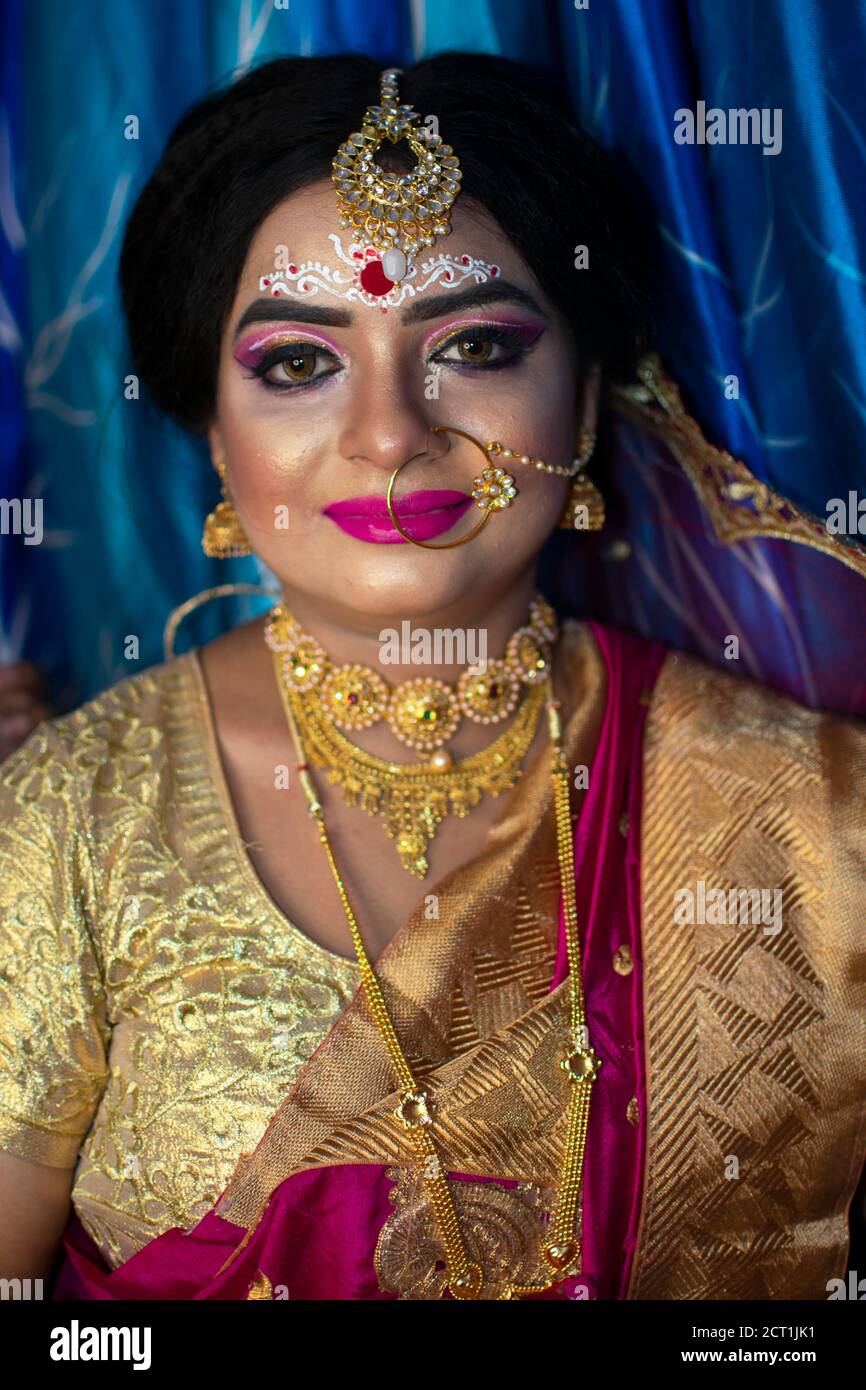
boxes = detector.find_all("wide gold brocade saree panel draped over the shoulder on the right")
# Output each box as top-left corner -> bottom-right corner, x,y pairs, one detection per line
628,644 -> 866,1300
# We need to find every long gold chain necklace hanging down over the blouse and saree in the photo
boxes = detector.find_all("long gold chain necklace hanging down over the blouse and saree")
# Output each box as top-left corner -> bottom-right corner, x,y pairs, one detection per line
272,639 -> 601,1300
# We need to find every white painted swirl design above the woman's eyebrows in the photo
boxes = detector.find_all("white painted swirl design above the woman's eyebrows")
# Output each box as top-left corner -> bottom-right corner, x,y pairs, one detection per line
259,232 -> 500,310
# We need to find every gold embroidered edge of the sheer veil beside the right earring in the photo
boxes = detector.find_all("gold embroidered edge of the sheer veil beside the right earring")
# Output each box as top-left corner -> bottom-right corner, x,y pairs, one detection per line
610,352 -> 866,578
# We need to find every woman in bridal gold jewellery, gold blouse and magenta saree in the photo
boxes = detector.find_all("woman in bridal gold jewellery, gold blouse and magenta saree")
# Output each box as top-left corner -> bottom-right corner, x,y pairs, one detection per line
0,54 -> 866,1300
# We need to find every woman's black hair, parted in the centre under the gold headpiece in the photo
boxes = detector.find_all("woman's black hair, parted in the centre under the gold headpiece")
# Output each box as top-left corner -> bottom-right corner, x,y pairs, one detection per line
120,51 -> 652,434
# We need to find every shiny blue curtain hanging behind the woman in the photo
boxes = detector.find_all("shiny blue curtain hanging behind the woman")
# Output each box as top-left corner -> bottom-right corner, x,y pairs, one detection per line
0,0 -> 866,712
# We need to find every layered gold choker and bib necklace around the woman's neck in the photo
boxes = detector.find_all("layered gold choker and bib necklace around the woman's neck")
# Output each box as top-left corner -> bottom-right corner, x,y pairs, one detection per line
264,595 -> 559,878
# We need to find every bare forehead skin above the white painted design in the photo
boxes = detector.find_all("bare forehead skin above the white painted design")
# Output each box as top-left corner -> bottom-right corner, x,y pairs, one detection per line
238,179 -> 534,297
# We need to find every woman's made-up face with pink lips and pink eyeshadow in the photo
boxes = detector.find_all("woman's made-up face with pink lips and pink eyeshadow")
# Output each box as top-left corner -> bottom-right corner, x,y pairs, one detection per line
210,179 -> 598,630
